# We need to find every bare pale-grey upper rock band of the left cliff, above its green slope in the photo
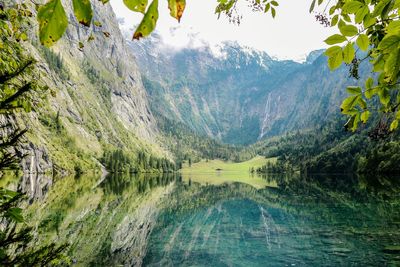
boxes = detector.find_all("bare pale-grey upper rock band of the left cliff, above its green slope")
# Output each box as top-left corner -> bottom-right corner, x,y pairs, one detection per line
56,1 -> 156,141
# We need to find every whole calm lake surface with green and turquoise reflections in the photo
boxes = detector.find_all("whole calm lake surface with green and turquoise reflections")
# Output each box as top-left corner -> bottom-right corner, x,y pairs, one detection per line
28,174 -> 400,266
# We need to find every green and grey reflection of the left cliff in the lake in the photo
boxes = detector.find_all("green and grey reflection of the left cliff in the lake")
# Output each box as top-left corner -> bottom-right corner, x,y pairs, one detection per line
27,174 -> 180,266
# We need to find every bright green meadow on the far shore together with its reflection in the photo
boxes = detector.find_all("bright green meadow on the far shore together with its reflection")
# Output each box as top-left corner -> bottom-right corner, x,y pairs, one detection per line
181,156 -> 277,189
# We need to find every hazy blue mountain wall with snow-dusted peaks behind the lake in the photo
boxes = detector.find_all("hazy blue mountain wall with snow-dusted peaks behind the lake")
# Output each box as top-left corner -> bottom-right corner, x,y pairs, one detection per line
128,35 -> 367,144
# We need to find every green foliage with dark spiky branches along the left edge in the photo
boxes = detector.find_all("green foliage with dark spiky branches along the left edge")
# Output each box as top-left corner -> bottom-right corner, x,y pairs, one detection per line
0,2 -> 67,266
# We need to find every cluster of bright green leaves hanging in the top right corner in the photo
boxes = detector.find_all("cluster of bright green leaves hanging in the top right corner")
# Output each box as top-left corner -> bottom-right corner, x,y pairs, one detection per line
318,0 -> 400,131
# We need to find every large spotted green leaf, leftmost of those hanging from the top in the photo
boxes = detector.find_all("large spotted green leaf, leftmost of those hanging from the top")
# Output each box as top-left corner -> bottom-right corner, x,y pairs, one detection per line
37,0 -> 68,47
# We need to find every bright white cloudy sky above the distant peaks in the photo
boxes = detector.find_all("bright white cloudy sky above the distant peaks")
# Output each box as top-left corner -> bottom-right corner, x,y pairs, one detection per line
111,0 -> 335,61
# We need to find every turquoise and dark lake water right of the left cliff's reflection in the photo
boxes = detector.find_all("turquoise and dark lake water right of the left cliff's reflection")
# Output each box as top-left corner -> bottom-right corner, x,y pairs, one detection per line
144,177 -> 400,266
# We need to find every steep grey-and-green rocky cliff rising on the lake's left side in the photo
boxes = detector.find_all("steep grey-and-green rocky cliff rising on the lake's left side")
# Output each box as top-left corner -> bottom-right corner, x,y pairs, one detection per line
12,1 -> 166,197
